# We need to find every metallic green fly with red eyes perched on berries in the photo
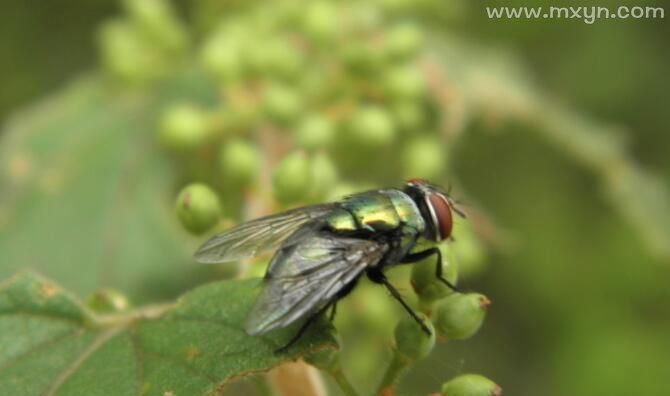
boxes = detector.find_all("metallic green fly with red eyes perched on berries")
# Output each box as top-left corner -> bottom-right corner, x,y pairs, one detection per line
195,179 -> 464,351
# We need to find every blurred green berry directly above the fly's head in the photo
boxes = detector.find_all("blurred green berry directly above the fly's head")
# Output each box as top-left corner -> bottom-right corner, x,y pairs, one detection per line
400,136 -> 447,180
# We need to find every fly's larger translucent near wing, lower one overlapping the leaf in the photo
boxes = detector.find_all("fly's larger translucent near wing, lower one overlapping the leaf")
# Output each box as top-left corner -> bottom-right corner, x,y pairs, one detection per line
246,226 -> 388,335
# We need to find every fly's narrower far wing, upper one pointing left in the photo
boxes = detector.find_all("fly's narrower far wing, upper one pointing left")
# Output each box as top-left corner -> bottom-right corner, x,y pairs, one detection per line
195,204 -> 334,264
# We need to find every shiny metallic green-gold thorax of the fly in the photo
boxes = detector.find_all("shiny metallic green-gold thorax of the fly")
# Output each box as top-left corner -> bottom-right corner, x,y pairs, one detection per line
326,189 -> 425,236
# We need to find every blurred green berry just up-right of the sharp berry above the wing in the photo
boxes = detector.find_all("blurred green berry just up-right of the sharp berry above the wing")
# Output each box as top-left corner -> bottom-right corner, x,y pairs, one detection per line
219,139 -> 261,184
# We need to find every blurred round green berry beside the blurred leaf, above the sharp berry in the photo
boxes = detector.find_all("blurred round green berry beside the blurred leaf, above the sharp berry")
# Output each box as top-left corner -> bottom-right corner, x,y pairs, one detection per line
159,104 -> 209,150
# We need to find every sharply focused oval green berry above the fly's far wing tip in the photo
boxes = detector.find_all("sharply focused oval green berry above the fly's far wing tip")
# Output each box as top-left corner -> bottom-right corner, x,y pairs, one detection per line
176,183 -> 221,234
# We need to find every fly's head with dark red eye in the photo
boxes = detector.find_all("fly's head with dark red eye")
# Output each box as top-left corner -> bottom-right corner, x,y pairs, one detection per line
403,179 -> 465,242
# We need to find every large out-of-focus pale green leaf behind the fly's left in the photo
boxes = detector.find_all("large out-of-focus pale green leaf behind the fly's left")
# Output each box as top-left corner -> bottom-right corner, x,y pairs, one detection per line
0,73 -> 218,301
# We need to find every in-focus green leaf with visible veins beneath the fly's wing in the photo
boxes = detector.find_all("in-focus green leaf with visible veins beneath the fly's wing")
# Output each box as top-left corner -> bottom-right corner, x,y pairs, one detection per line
0,274 -> 336,396
